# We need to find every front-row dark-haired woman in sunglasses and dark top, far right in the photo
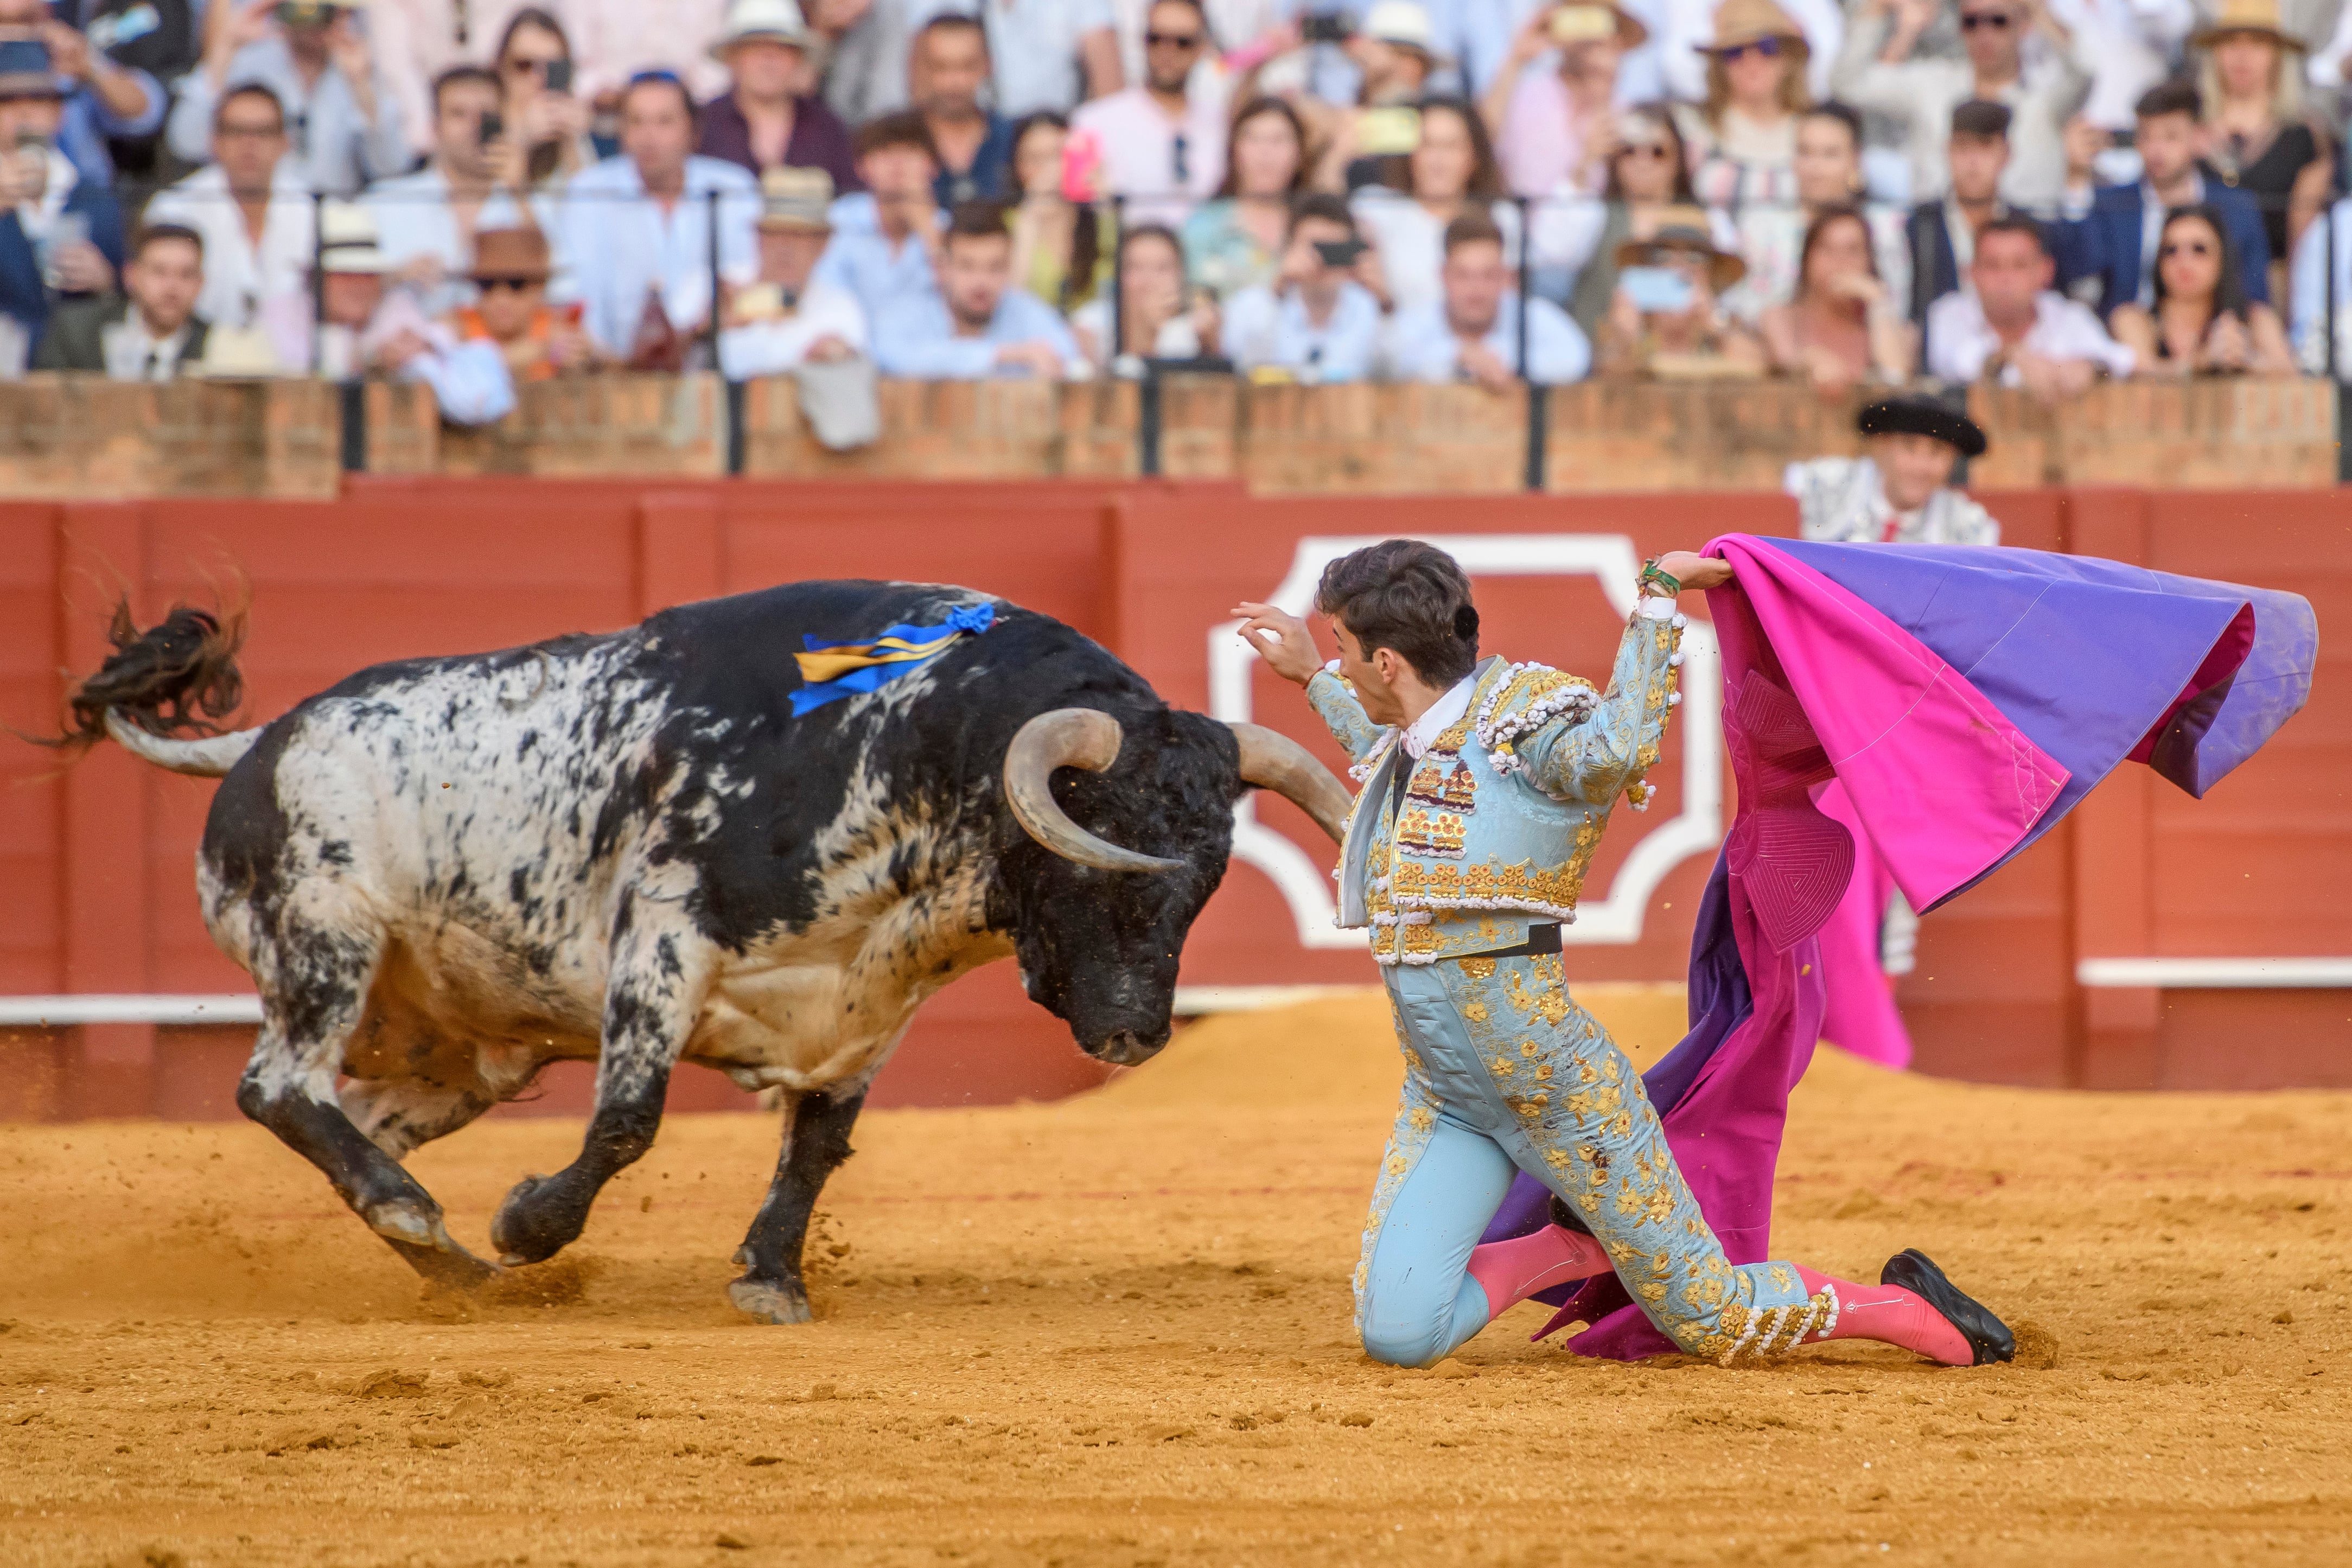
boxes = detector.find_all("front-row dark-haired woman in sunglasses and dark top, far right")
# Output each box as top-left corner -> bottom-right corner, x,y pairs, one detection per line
2107,207 -> 2296,376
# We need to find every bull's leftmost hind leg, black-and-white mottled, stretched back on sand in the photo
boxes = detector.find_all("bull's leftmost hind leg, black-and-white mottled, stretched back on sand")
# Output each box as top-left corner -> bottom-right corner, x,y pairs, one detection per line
238,919 -> 496,1286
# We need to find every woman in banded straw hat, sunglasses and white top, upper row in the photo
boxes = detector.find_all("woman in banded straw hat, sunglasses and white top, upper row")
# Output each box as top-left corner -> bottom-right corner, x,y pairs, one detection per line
1682,0 -> 1813,207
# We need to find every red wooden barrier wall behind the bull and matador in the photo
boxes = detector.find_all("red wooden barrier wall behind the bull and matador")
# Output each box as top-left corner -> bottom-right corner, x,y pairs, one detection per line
0,480 -> 2352,1117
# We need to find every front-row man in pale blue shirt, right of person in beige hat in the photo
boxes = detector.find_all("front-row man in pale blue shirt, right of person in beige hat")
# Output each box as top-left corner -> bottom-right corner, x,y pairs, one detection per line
875,202 -> 1084,381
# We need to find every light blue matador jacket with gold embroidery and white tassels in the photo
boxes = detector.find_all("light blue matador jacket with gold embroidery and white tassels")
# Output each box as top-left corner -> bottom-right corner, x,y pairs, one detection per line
1308,600 -> 1684,964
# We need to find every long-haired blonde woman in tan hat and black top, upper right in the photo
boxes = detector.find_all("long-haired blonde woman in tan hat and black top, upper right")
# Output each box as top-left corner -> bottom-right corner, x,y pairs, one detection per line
2190,0 -> 2336,298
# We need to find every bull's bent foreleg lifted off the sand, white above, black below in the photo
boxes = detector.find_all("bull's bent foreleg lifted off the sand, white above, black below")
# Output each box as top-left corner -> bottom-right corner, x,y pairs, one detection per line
489,896 -> 717,1265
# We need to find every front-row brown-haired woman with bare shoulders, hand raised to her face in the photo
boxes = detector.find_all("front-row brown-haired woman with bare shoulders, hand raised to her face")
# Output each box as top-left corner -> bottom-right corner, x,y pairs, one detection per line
1764,207 -> 1912,400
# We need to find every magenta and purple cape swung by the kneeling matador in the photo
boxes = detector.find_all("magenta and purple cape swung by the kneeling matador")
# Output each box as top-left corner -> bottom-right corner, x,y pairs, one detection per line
1484,536 -> 2317,1359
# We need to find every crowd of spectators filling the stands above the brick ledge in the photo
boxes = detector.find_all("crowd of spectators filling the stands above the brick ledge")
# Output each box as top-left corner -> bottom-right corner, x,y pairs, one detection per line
0,0 -> 2352,418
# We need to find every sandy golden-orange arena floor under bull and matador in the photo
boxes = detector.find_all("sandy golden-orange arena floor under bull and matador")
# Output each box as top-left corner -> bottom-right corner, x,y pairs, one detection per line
0,999 -> 2352,1568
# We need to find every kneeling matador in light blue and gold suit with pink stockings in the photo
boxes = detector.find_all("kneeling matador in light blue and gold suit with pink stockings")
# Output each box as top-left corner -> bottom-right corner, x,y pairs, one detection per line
1235,541 -> 2013,1366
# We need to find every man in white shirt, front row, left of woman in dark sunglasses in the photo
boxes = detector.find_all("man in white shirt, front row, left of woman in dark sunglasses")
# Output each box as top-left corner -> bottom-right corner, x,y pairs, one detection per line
1926,216 -> 2133,402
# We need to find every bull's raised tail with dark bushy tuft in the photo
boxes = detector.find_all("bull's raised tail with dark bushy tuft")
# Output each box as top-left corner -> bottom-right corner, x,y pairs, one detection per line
44,600 -> 261,778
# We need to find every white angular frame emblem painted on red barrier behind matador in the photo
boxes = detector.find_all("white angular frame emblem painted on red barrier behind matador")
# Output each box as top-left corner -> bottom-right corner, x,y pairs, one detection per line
1209,534 -> 1724,947
